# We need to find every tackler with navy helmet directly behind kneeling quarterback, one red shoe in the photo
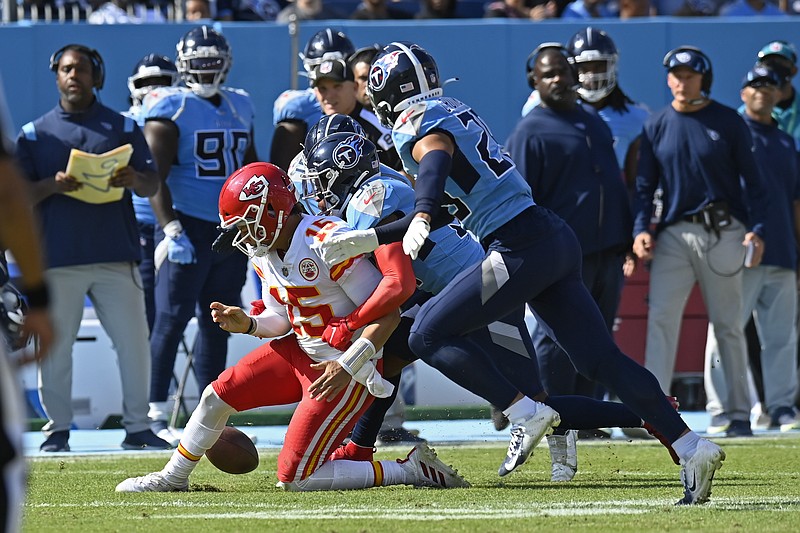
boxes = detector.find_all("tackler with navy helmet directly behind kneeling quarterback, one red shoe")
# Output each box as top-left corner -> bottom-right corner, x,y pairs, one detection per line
300,132 -> 664,475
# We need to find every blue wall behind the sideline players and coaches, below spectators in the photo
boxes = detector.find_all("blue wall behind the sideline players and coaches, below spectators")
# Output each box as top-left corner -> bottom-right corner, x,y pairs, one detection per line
0,18 -> 800,159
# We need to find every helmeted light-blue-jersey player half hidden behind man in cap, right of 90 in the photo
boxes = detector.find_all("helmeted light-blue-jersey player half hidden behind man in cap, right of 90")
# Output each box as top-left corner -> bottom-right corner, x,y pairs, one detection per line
269,28 -> 356,169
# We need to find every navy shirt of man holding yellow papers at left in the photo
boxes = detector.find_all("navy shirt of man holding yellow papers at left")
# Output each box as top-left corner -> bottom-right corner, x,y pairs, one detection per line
16,100 -> 155,268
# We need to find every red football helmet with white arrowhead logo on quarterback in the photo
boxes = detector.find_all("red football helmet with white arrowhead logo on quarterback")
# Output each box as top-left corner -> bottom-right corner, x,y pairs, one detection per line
219,163 -> 297,257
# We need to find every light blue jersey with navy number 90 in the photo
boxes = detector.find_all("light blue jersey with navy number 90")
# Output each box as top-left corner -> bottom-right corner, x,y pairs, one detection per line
142,87 -> 254,222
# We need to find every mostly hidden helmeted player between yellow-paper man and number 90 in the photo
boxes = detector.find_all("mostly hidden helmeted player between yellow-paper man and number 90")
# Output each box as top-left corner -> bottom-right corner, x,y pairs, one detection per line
123,54 -> 180,331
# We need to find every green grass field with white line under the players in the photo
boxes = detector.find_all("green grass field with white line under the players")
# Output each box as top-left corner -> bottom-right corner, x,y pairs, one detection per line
23,432 -> 800,533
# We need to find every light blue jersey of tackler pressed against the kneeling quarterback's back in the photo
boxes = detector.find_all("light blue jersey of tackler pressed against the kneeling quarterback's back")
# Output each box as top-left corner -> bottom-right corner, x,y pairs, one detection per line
344,176 -> 485,294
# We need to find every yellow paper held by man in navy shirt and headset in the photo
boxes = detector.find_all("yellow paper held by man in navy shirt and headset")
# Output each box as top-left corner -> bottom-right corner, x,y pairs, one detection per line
64,143 -> 133,204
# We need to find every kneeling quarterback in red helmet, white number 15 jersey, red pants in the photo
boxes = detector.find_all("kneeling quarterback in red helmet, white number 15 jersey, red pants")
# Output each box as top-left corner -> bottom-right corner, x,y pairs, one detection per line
111,163 -> 462,492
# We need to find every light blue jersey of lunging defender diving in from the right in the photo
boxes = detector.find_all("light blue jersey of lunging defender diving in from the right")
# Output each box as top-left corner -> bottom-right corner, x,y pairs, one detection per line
392,98 -> 534,240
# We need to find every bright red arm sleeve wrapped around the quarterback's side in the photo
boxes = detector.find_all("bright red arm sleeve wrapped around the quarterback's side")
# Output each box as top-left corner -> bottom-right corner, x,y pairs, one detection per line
347,243 -> 416,330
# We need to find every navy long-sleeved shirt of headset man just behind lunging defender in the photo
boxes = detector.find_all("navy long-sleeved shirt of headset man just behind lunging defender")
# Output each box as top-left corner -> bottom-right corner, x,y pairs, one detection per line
506,105 -> 633,255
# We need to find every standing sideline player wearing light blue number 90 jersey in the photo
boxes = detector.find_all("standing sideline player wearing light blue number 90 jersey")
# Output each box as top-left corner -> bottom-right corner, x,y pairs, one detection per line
142,26 -> 257,442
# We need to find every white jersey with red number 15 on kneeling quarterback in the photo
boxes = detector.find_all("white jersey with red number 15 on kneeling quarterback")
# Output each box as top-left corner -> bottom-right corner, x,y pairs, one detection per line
252,215 -> 382,361
